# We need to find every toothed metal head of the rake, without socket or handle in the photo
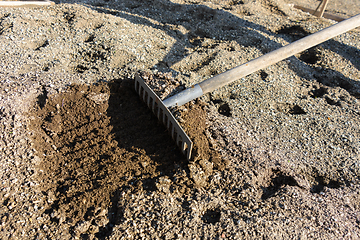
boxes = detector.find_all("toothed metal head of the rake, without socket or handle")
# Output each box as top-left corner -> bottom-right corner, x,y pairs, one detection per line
135,75 -> 193,160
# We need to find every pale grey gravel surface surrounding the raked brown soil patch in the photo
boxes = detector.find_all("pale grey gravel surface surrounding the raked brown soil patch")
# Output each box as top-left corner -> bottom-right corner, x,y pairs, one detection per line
0,0 -> 360,239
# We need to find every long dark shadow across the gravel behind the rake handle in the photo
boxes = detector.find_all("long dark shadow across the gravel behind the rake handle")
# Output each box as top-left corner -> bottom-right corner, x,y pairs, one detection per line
59,0 -> 360,98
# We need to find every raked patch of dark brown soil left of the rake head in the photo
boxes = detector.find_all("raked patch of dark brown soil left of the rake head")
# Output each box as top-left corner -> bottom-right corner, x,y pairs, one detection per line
30,81 -> 199,236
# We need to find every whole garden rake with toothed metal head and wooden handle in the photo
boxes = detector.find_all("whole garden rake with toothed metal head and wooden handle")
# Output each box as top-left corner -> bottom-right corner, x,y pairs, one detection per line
135,14 -> 360,160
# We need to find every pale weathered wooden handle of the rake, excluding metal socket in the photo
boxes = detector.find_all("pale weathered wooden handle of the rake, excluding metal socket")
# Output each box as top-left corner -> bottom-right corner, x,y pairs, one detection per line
199,14 -> 360,94
